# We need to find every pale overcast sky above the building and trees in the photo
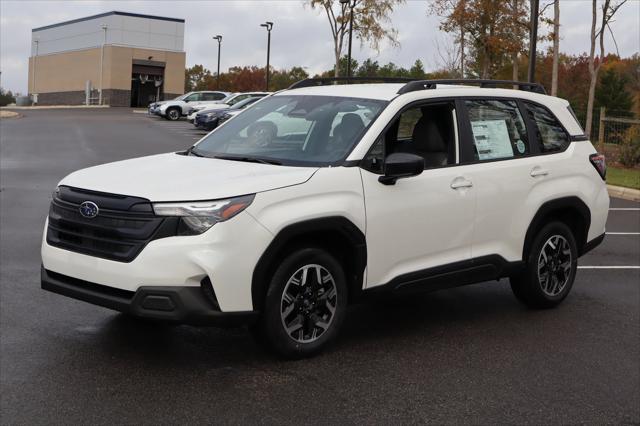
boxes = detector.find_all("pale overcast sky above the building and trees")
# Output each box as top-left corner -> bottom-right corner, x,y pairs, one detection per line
0,0 -> 640,93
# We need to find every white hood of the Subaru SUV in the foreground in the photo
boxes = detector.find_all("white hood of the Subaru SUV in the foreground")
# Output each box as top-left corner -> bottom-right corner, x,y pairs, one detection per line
59,153 -> 317,201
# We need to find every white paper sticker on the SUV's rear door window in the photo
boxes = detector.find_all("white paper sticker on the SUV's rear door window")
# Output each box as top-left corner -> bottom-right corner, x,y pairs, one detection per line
471,120 -> 513,160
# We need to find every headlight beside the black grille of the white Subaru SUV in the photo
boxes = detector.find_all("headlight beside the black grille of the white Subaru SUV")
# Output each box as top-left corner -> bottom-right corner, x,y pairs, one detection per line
153,194 -> 255,235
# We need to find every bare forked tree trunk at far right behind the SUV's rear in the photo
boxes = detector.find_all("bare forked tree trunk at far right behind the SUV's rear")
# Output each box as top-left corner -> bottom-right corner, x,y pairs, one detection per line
584,0 -> 627,137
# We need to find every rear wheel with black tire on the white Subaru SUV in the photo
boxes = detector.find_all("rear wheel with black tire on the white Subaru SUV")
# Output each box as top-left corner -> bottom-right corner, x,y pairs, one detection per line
510,222 -> 578,309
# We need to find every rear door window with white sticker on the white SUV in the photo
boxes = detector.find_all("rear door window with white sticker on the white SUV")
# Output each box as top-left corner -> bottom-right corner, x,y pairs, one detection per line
465,100 -> 530,161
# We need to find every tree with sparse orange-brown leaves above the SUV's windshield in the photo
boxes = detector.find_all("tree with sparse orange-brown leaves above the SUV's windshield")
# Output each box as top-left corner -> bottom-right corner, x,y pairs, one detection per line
307,0 -> 404,77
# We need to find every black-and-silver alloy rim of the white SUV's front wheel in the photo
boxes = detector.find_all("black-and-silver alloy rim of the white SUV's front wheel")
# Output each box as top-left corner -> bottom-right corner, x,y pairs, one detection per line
280,264 -> 338,343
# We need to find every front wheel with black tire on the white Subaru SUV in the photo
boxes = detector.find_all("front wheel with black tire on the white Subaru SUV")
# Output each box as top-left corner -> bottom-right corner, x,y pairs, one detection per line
253,247 -> 348,359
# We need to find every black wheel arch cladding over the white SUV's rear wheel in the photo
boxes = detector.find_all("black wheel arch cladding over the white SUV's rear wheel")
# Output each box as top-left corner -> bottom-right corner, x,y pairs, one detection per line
522,196 -> 591,261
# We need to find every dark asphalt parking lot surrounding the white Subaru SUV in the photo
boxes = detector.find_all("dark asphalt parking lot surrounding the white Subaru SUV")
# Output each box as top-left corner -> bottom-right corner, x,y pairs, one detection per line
0,108 -> 640,424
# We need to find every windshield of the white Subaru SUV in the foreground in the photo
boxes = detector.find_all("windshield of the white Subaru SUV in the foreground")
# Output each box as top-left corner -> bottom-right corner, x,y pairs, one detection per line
190,95 -> 387,166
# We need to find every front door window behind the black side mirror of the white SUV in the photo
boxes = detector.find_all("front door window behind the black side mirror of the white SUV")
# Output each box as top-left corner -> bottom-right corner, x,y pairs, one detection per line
384,102 -> 456,168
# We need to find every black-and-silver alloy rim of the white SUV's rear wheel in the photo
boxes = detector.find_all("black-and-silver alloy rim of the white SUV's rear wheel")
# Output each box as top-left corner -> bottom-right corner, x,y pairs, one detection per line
538,235 -> 572,297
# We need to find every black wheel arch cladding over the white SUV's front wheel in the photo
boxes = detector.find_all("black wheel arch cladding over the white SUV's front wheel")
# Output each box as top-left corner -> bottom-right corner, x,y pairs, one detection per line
251,216 -> 367,310
